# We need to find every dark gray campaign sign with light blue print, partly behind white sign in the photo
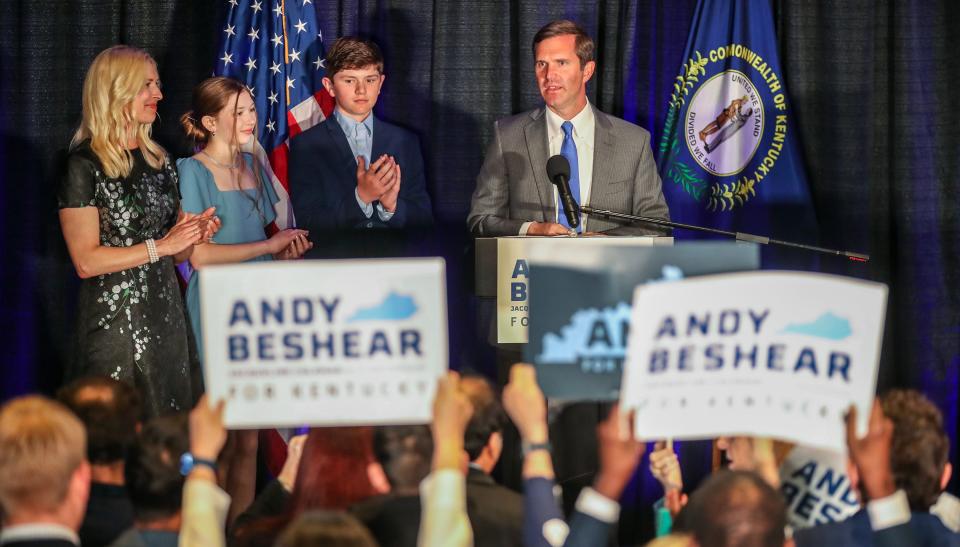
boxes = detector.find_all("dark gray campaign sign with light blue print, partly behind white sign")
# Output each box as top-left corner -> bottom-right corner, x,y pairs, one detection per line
524,244 -> 760,401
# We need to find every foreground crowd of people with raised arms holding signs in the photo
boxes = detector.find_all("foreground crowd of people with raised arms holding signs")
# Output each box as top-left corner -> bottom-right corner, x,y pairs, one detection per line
0,363 -> 960,547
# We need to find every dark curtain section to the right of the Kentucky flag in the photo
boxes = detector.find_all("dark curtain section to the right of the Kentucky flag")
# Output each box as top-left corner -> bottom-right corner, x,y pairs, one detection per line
778,0 -> 960,491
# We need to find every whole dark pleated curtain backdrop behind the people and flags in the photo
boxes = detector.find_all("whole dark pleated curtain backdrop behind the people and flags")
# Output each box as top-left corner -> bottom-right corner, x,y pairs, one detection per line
0,0 -> 960,540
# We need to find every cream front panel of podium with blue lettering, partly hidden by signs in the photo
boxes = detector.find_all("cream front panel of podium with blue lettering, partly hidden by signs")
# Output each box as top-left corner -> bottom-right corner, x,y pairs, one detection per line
497,236 -> 673,344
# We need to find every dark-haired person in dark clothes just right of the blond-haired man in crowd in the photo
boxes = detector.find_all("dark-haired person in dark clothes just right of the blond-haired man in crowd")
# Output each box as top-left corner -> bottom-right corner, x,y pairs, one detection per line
57,376 -> 141,547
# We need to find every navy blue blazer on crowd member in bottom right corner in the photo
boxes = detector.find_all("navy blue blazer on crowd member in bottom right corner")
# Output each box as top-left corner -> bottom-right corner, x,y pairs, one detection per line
793,509 -> 960,547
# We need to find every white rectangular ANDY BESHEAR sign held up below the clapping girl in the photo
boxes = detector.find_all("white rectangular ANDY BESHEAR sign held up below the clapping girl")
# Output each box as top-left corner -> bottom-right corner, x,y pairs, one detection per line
200,258 -> 448,428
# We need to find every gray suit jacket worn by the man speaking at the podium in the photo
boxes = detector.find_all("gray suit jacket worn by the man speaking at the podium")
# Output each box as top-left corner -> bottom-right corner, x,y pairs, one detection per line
467,104 -> 670,237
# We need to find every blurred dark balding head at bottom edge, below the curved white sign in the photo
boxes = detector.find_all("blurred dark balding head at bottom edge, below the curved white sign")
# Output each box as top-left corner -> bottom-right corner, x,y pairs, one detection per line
677,471 -> 787,547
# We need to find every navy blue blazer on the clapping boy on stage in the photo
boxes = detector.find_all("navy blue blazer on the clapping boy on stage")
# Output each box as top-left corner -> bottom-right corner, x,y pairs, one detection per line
287,116 -> 433,232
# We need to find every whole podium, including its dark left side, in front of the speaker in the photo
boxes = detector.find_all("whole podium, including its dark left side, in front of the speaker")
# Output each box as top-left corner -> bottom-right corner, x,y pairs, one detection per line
474,236 -> 673,346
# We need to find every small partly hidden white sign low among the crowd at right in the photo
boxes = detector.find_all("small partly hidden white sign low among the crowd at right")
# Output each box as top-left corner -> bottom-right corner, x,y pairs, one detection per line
780,446 -> 860,530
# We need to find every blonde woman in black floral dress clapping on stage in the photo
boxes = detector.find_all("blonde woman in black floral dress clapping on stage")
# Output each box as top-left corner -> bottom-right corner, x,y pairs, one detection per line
57,46 -> 218,416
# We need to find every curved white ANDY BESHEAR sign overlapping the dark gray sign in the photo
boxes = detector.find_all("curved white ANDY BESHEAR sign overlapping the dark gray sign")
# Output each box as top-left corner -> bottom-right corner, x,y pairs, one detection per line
621,272 -> 887,453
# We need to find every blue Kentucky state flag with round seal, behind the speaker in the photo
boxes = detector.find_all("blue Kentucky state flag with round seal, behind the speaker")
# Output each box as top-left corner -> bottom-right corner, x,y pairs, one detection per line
656,0 -> 817,248
